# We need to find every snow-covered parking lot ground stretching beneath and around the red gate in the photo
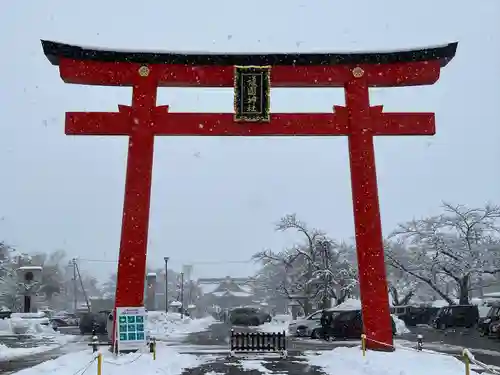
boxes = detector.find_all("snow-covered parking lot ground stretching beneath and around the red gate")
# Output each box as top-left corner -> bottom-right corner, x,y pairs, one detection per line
0,312 -> 500,375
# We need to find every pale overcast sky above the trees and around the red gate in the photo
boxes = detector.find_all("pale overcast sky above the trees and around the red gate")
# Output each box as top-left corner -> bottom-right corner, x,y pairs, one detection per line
0,0 -> 500,277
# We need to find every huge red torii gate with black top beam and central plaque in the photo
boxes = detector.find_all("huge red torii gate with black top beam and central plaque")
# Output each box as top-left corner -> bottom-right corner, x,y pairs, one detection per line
42,41 -> 457,350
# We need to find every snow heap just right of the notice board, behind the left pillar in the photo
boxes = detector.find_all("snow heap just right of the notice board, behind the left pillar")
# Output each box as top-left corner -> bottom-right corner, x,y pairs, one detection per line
147,311 -> 215,340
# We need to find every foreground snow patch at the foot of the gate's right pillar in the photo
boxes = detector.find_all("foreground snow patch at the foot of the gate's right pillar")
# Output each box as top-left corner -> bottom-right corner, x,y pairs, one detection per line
307,347 -> 477,375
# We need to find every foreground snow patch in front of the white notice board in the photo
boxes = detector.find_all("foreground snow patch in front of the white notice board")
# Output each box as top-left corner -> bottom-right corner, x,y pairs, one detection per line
8,343 -> 205,375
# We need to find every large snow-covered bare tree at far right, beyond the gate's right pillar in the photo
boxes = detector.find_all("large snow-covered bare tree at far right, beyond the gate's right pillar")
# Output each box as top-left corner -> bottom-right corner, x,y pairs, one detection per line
386,203 -> 500,304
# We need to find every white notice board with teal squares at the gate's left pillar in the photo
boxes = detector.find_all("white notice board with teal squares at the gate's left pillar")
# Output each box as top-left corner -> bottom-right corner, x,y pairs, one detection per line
116,307 -> 146,352
